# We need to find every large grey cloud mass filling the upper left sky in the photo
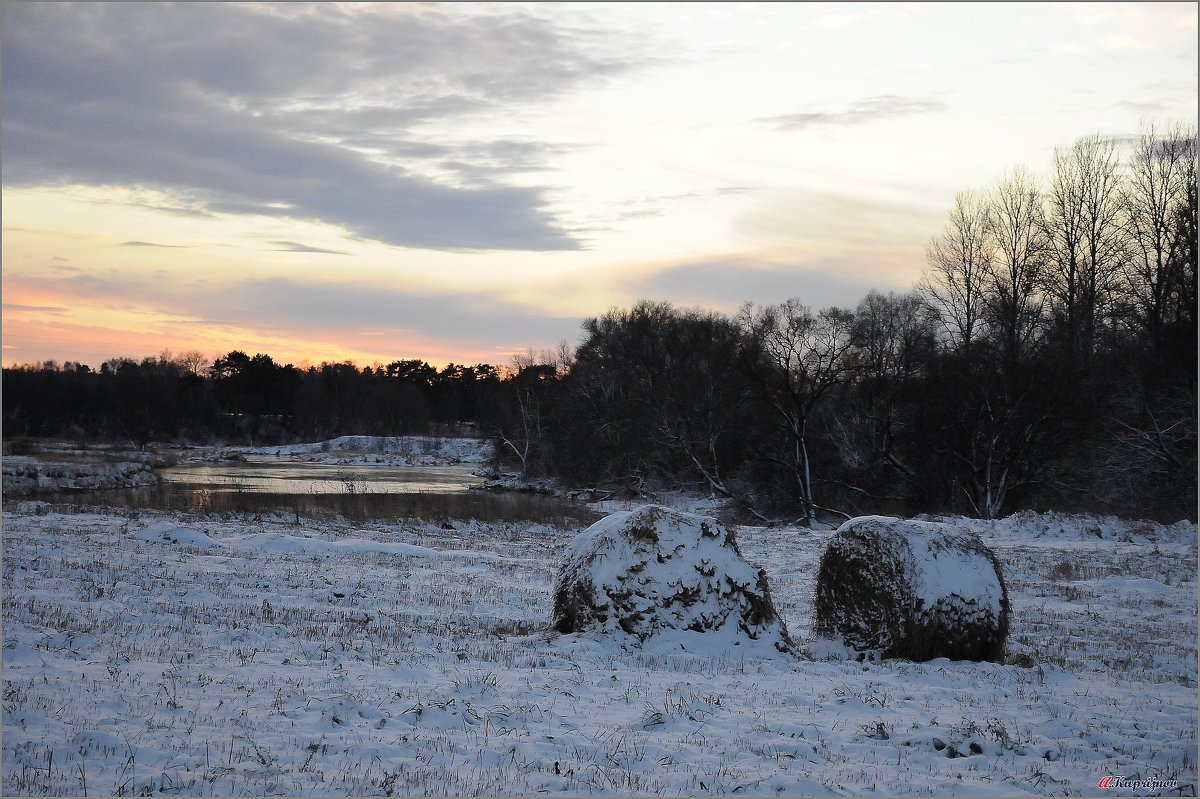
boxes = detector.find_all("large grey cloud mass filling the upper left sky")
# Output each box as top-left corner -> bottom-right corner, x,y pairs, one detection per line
4,4 -> 631,250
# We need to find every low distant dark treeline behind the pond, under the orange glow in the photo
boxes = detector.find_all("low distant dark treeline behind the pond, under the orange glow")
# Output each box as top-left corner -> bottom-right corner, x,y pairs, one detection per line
4,350 -> 505,446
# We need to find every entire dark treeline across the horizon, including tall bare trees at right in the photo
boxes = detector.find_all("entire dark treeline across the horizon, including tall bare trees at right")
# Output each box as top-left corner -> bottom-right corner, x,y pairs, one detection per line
4,125 -> 1196,522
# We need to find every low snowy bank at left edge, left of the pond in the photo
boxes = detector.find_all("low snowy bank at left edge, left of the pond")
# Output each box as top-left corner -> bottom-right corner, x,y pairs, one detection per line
4,452 -> 161,498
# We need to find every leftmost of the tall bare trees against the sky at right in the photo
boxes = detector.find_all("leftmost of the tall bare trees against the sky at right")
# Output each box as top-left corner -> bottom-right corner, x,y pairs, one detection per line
917,191 -> 995,356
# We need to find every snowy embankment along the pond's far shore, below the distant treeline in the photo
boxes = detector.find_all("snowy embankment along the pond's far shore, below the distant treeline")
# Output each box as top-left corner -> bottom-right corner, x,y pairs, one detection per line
216,435 -> 493,467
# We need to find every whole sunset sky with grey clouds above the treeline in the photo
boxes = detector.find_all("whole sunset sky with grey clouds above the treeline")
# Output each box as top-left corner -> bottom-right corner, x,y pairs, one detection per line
0,2 -> 1198,366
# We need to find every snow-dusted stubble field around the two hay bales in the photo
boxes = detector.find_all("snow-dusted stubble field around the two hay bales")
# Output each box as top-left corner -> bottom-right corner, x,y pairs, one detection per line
2,503 -> 1198,795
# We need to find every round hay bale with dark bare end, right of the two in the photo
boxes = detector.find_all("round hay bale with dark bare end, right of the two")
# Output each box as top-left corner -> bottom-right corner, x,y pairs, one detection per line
814,516 -> 1009,661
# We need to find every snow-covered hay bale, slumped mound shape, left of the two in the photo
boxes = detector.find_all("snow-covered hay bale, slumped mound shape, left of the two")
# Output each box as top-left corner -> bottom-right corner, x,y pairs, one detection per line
553,505 -> 792,651
